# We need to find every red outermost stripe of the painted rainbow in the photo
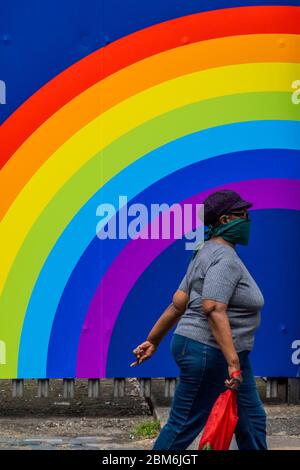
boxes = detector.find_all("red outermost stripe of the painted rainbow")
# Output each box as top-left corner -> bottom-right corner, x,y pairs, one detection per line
0,6 -> 300,167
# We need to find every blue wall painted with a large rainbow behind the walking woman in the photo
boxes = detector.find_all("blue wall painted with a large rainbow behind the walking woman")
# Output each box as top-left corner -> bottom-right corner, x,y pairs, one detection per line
0,0 -> 300,378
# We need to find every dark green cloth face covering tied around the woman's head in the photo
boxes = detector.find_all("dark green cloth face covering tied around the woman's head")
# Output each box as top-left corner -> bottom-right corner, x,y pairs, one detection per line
204,219 -> 251,245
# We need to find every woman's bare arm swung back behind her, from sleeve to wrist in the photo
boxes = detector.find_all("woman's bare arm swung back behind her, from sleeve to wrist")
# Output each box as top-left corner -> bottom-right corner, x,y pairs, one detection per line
147,289 -> 189,346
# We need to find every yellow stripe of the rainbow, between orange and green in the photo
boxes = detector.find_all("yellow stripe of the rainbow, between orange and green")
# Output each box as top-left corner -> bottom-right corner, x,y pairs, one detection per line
0,63 -> 300,292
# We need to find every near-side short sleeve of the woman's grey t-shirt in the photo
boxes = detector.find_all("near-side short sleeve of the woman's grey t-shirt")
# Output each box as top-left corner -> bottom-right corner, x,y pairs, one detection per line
202,252 -> 242,304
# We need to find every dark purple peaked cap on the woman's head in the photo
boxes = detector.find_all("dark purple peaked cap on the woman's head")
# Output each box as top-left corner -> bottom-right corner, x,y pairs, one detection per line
202,189 -> 253,225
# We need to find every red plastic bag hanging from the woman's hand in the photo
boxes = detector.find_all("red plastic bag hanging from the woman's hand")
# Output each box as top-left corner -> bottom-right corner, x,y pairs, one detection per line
198,390 -> 239,450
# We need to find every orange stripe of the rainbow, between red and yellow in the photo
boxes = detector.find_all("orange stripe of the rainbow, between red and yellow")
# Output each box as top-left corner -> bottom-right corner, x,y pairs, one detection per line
0,35 -> 300,217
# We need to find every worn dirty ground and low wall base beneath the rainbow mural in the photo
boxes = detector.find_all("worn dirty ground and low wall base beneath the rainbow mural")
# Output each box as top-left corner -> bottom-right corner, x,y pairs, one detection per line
0,378 -> 300,450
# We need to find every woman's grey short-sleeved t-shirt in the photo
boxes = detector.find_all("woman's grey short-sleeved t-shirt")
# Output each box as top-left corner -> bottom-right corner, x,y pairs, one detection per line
174,240 -> 264,352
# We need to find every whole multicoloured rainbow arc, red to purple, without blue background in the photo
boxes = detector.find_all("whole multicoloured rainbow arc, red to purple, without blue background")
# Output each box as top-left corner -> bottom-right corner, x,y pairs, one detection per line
0,1 -> 300,378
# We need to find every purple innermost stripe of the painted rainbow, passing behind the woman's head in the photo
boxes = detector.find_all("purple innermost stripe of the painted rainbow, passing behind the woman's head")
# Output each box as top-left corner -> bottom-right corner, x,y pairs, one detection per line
76,179 -> 300,378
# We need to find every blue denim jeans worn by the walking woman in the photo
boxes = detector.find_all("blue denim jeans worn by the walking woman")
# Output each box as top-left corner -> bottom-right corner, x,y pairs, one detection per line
152,333 -> 268,450
